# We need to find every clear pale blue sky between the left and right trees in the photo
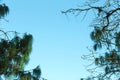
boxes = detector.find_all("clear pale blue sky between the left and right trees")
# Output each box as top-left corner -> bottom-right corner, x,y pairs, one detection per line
0,0 -> 92,80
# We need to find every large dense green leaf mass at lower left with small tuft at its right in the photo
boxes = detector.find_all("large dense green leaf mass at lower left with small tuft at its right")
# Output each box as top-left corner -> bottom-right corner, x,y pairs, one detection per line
0,34 -> 41,80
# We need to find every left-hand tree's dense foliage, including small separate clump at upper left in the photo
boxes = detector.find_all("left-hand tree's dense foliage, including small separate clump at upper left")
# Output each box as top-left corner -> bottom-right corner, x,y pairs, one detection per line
0,0 -> 41,80
